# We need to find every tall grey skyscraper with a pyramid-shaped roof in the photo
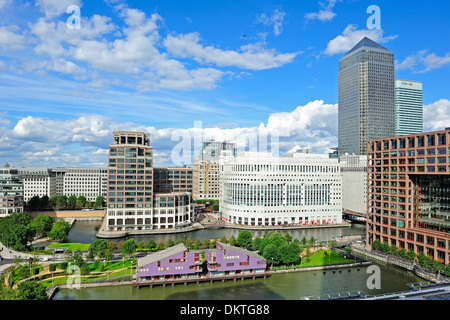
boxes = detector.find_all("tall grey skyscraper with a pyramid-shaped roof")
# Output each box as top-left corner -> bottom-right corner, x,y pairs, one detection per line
338,37 -> 395,156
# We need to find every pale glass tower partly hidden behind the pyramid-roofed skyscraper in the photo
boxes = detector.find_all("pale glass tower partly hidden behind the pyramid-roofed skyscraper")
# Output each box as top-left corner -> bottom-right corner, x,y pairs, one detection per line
395,80 -> 423,136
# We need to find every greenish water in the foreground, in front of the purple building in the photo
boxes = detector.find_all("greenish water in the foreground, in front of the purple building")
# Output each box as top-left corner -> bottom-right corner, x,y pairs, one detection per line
53,264 -> 423,300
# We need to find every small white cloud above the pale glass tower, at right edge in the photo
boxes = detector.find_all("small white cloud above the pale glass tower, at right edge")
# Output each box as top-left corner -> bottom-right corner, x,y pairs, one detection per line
395,50 -> 450,73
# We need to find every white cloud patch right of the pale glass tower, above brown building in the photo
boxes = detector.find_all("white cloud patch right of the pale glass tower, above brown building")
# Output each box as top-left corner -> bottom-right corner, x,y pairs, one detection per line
423,99 -> 450,132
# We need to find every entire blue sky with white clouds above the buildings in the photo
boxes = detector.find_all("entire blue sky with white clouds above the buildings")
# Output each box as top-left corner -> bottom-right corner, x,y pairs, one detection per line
0,0 -> 450,168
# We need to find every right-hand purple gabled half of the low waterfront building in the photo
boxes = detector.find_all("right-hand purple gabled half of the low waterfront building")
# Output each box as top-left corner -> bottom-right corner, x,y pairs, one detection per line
205,242 -> 266,277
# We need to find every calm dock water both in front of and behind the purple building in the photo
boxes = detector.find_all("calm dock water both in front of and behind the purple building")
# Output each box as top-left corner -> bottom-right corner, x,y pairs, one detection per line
53,222 -> 424,300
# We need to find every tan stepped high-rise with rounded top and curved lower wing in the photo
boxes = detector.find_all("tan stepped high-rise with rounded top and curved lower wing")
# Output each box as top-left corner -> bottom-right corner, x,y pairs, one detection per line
107,131 -> 194,231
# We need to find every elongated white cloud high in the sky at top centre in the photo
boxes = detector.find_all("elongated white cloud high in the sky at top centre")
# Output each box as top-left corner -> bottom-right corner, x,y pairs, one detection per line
164,32 -> 298,70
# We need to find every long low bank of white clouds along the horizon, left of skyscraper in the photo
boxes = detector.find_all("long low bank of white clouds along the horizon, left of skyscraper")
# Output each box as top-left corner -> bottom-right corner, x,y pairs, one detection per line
0,101 -> 337,166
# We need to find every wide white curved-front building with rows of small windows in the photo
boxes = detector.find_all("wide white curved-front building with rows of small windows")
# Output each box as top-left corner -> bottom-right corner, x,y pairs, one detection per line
220,152 -> 342,226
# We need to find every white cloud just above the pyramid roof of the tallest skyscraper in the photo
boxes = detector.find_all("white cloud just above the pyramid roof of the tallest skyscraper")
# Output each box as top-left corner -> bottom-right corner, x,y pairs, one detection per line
325,24 -> 397,56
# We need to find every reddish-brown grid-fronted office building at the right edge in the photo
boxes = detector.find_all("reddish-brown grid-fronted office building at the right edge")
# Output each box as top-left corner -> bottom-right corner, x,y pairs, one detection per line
366,129 -> 450,264
